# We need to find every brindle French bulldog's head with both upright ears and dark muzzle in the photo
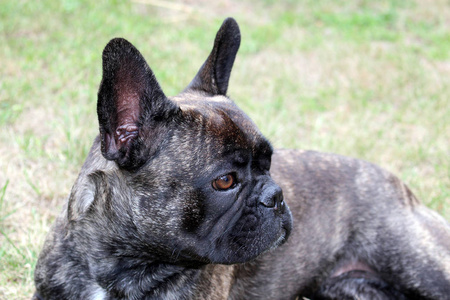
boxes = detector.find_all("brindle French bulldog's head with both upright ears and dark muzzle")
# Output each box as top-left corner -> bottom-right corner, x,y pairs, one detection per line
69,19 -> 292,263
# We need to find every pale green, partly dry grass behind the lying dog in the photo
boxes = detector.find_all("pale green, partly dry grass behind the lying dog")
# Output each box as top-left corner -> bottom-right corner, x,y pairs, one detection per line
0,0 -> 450,299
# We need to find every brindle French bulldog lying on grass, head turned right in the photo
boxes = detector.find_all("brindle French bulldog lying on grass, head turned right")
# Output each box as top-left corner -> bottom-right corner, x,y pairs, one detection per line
33,18 -> 450,300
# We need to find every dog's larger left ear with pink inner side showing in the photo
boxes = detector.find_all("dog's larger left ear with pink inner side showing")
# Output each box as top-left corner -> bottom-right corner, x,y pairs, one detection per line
97,38 -> 177,169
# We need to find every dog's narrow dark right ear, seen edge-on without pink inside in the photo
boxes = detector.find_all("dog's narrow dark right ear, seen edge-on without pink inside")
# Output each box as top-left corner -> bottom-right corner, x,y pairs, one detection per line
185,18 -> 241,95
